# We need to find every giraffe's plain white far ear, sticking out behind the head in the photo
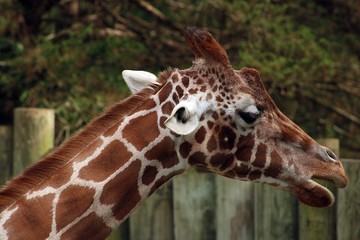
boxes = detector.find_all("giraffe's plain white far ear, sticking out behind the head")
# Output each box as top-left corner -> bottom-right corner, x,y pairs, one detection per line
122,70 -> 159,94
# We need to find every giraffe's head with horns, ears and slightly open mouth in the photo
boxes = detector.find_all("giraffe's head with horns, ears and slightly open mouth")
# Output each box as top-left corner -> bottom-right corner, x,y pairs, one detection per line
123,28 -> 348,207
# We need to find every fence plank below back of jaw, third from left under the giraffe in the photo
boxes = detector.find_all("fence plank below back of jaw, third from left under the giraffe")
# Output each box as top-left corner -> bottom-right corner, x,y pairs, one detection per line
173,171 -> 216,240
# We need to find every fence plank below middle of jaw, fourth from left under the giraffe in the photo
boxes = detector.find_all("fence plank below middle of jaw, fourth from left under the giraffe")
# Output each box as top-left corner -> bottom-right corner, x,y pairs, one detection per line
216,175 -> 254,240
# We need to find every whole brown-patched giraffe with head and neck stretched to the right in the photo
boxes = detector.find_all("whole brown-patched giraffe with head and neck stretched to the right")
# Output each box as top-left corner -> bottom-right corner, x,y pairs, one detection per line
0,27 -> 348,240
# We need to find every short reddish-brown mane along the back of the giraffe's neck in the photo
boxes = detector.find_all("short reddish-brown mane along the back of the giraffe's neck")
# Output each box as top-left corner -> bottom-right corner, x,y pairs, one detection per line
0,68 -> 172,213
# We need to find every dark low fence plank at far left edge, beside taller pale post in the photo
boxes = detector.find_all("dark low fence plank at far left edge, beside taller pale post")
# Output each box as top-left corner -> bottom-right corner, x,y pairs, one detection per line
0,126 -> 13,186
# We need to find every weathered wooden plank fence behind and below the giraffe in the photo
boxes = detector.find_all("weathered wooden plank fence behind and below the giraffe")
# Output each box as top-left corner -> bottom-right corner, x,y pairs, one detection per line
0,109 -> 360,240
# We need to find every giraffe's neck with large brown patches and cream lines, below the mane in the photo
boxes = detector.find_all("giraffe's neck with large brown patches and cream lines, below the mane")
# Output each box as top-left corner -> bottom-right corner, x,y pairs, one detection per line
0,87 -> 187,239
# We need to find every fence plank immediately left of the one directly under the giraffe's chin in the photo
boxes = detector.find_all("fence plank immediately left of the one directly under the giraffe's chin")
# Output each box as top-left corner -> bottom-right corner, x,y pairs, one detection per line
254,184 -> 298,240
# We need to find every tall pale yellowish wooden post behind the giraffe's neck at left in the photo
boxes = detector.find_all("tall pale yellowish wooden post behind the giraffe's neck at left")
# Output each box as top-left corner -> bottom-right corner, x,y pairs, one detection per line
13,108 -> 55,175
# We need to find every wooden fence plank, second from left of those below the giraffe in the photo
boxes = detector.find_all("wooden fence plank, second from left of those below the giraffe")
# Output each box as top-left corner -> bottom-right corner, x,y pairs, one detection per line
130,182 -> 174,240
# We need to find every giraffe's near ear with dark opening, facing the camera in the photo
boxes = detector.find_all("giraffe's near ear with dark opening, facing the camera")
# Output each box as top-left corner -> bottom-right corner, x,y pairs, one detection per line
165,101 -> 199,135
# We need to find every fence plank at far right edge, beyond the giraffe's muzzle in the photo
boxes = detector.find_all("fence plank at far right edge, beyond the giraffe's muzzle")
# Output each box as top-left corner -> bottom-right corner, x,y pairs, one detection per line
337,160 -> 360,240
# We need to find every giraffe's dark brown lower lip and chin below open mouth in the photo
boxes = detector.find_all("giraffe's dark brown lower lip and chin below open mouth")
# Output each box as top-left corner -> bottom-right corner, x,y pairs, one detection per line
290,179 -> 335,208
